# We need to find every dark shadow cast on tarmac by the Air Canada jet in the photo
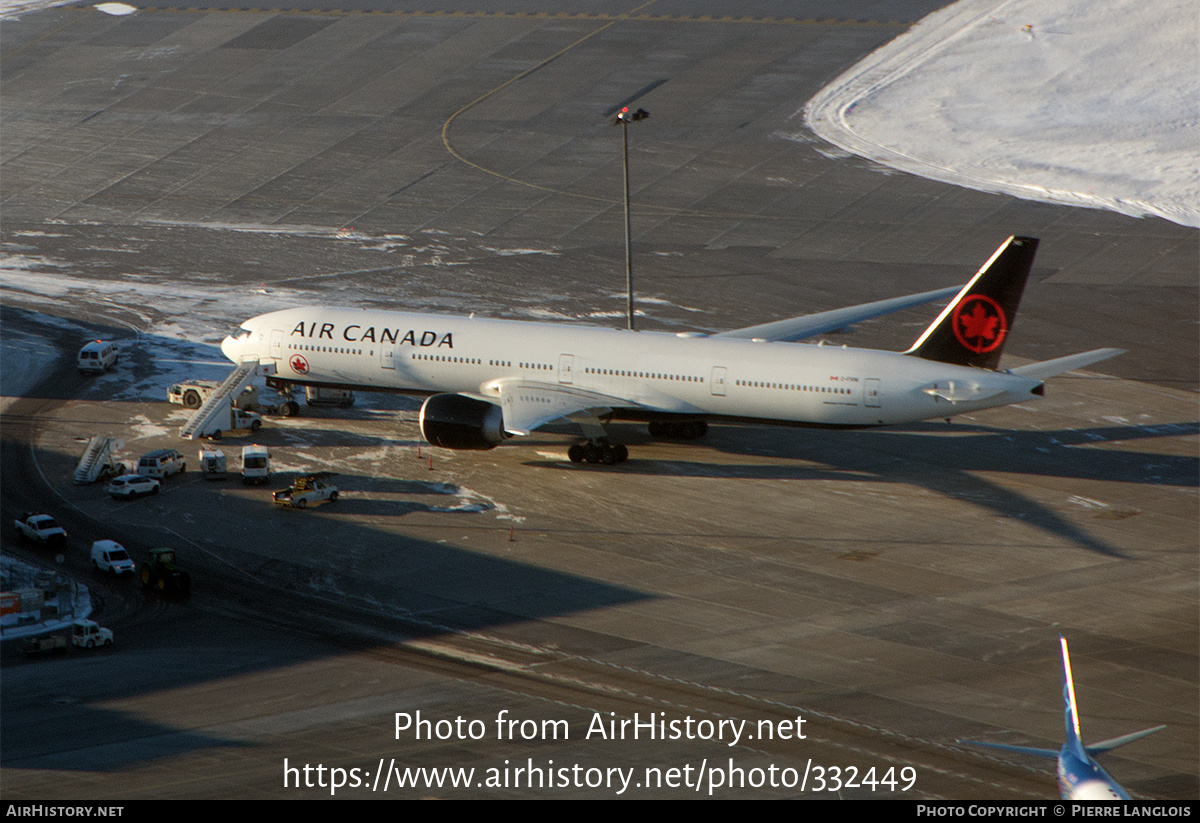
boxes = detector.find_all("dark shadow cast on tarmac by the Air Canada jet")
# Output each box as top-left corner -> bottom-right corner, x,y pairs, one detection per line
526,421 -> 1200,558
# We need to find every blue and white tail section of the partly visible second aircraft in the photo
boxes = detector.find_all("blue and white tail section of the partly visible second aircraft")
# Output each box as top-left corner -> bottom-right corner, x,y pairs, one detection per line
959,637 -> 1166,800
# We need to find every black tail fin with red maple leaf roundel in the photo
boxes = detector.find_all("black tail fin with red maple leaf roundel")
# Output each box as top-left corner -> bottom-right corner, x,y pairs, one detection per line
905,238 -> 1038,368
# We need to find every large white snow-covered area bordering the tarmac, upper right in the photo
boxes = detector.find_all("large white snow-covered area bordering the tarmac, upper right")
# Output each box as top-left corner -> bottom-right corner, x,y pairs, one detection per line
804,0 -> 1200,226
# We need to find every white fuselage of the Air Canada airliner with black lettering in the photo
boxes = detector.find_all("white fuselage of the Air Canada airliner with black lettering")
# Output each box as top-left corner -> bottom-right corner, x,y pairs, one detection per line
221,308 -> 1040,426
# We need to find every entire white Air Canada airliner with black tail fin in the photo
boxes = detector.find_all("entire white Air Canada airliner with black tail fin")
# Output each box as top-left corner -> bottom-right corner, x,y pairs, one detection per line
221,238 -> 1121,464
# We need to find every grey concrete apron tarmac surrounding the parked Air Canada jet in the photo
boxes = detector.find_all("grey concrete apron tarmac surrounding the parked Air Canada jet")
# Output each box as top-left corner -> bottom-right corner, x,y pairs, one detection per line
0,2 -> 1200,800
